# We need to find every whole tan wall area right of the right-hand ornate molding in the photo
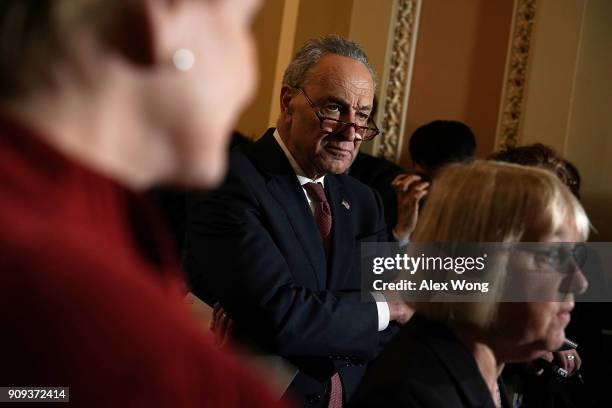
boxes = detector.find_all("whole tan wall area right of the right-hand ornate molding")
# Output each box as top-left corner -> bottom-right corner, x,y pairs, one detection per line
520,0 -> 612,241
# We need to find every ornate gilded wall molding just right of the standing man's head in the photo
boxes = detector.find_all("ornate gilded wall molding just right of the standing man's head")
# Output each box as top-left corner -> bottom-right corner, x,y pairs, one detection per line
375,0 -> 420,162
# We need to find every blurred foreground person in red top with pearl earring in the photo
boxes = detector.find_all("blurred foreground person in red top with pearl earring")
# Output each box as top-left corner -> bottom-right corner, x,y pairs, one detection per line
0,0 -> 288,407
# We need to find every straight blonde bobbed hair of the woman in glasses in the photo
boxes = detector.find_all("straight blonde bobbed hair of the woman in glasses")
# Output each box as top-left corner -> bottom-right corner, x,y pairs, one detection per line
412,161 -> 590,327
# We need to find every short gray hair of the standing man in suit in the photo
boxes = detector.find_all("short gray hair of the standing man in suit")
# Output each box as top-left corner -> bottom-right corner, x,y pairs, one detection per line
283,34 -> 376,89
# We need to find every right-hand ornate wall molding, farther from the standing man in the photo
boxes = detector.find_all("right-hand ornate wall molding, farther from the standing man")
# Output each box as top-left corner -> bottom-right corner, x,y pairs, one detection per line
497,0 -> 536,149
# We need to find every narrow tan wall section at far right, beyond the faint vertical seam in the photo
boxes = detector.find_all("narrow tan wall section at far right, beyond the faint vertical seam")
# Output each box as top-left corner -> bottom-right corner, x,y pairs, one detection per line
565,0 -> 612,241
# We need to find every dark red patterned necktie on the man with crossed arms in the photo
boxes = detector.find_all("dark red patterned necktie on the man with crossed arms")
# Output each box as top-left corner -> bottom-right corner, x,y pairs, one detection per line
304,183 -> 342,408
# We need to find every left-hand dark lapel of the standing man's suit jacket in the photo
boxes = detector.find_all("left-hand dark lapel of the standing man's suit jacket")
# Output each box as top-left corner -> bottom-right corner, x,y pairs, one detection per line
245,129 -> 327,289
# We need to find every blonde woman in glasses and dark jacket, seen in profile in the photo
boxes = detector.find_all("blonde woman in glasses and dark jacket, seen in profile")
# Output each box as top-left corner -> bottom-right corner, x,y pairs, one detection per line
355,162 -> 589,407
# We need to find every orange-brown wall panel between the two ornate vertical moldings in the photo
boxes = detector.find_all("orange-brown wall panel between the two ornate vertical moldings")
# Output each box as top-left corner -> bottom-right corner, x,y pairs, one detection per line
400,0 -> 513,167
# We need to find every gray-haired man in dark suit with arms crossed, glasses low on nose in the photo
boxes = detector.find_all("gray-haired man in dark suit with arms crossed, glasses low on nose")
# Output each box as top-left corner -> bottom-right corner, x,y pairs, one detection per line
185,36 -> 412,407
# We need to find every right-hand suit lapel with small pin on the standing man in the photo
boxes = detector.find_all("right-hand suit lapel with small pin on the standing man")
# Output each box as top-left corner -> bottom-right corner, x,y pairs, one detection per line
325,175 -> 354,289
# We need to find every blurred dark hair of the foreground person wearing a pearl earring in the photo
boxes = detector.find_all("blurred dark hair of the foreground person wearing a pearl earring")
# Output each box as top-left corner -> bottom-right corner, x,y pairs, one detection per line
0,0 -> 117,98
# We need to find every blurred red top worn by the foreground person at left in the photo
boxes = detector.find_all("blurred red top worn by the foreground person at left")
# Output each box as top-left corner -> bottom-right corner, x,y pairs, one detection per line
0,112 -> 286,407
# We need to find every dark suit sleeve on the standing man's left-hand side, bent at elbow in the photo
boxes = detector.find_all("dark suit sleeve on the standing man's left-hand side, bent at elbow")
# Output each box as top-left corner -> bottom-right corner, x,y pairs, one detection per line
186,163 -> 379,360
